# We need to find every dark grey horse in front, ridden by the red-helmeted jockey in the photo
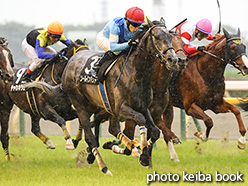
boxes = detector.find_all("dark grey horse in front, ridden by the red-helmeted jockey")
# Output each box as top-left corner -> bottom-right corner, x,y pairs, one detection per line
59,18 -> 178,175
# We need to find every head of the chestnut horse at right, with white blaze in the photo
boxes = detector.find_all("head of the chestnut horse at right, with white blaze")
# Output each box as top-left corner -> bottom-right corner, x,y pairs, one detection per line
223,28 -> 248,76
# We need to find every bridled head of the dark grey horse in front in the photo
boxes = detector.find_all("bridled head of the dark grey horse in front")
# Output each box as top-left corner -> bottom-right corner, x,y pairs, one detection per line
140,18 -> 178,70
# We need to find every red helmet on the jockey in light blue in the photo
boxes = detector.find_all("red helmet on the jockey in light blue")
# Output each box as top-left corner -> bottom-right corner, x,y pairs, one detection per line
125,7 -> 145,24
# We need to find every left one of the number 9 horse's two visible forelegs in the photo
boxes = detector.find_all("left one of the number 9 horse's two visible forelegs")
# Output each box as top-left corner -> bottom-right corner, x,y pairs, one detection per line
31,115 -> 55,149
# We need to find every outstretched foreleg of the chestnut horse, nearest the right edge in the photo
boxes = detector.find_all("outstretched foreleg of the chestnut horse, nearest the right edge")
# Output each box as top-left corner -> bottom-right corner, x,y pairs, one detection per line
216,100 -> 246,149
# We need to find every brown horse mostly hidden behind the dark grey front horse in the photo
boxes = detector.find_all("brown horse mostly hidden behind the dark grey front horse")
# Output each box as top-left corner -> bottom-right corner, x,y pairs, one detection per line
92,28 -> 187,164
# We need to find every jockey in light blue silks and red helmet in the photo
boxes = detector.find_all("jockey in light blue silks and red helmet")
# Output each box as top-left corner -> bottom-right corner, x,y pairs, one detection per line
96,7 -> 144,66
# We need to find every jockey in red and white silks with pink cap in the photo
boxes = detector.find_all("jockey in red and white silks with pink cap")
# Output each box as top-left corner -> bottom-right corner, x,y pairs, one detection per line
176,19 -> 213,55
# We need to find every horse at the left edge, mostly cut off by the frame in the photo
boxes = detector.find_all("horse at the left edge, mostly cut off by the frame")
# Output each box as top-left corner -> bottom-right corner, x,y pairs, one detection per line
0,38 -> 14,161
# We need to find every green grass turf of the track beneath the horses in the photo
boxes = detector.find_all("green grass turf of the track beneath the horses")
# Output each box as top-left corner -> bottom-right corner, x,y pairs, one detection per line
0,136 -> 248,186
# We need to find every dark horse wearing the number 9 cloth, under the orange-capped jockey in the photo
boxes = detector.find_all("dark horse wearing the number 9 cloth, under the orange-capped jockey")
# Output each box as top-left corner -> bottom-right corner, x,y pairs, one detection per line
8,40 -> 88,150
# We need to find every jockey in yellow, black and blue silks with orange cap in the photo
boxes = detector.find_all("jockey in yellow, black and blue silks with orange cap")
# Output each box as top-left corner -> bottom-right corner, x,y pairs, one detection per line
22,21 -> 71,80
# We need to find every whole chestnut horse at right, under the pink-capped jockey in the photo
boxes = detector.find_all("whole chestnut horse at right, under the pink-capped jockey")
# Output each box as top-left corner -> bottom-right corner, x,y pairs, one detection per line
163,29 -> 248,149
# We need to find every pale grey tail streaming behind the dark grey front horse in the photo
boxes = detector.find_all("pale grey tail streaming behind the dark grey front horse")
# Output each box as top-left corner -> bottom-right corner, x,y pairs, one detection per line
23,81 -> 62,96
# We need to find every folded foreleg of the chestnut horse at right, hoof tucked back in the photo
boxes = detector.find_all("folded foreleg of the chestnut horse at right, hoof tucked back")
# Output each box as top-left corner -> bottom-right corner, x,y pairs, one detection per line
185,103 -> 213,141
